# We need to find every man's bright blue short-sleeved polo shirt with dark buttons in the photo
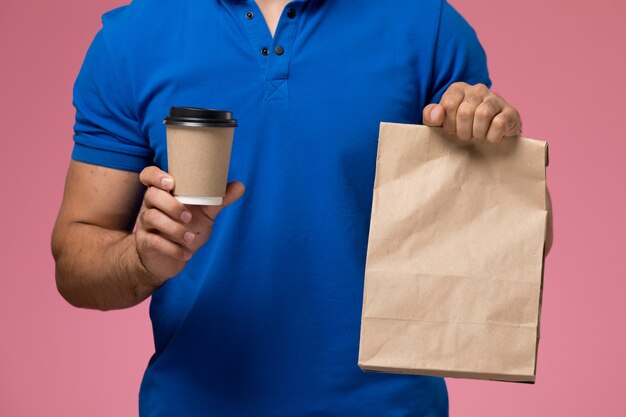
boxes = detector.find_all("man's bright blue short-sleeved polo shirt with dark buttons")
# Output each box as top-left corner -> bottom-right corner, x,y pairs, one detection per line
72,0 -> 489,417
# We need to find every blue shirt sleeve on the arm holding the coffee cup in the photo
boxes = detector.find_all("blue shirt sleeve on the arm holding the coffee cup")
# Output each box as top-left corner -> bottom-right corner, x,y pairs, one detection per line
72,29 -> 153,172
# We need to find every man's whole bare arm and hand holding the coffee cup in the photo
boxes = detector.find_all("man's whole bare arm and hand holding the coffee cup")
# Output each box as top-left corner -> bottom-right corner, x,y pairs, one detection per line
52,161 -> 244,310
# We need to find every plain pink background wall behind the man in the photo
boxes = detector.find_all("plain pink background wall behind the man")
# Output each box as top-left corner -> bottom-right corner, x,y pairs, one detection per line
0,0 -> 626,417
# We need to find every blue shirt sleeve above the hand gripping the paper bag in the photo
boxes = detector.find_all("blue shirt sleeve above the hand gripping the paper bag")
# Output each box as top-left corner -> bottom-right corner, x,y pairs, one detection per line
427,1 -> 491,103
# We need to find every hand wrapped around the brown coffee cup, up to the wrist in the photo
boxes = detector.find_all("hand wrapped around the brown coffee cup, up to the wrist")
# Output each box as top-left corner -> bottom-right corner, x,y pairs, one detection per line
135,166 -> 244,286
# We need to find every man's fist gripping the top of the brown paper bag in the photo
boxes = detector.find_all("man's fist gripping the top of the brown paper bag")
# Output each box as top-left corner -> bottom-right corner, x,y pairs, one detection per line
423,82 -> 522,143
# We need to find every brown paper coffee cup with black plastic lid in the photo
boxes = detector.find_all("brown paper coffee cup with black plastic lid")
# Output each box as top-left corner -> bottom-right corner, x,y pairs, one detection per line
164,107 -> 237,205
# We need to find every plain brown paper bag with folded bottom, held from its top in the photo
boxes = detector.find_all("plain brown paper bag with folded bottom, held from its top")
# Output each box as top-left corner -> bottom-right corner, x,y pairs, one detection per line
358,123 -> 547,382
